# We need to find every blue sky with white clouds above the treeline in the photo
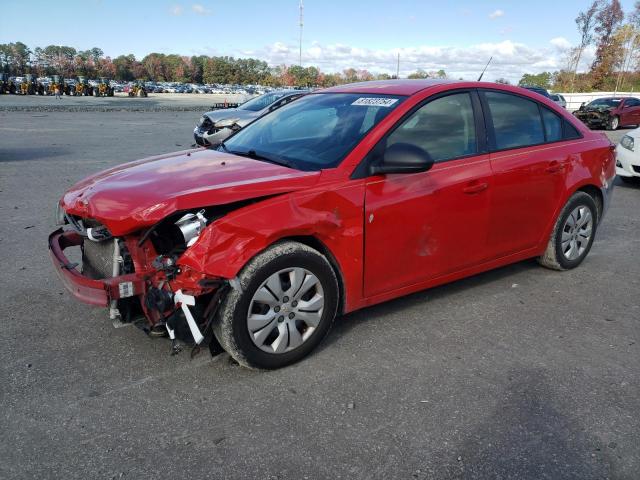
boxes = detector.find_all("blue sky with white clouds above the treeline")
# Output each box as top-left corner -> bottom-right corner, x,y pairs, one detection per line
0,0 -> 633,79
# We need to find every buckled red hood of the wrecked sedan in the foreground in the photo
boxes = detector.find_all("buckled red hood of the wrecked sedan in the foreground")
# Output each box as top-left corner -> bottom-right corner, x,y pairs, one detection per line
61,149 -> 320,236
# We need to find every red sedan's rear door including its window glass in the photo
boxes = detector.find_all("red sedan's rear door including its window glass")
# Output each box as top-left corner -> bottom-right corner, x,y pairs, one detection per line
480,90 -> 575,258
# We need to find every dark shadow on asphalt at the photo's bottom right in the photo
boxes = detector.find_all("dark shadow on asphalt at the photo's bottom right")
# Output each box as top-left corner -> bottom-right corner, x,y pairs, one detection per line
435,368 -> 619,480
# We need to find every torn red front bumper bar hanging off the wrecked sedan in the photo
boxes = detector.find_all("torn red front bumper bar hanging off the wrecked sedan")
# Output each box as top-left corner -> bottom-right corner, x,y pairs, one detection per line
49,229 -> 146,307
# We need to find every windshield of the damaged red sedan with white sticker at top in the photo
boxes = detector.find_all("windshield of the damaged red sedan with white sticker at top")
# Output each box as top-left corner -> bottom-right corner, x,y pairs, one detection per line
221,93 -> 404,170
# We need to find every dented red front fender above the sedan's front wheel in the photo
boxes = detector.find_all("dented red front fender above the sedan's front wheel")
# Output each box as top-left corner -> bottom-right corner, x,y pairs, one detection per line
178,180 -> 364,313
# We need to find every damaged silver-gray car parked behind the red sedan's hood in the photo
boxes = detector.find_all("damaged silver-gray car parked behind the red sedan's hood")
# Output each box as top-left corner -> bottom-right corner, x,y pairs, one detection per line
193,90 -> 308,147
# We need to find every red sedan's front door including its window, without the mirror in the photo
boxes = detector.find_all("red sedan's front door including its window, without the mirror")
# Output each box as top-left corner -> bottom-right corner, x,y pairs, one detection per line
364,92 -> 492,297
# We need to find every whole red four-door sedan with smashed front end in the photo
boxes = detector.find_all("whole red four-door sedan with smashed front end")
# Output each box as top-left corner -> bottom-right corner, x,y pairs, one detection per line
49,80 -> 615,368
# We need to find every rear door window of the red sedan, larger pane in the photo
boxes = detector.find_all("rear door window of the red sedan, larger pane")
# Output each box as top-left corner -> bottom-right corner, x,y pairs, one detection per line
484,92 -> 545,150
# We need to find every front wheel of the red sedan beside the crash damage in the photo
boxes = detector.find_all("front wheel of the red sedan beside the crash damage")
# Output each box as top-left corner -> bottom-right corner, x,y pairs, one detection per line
213,241 -> 339,369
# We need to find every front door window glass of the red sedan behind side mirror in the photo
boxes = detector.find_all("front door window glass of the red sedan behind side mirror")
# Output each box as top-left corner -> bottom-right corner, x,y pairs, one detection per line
387,92 -> 478,162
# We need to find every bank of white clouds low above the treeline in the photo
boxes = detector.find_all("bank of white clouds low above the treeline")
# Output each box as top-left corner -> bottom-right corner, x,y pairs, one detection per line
235,40 -> 576,83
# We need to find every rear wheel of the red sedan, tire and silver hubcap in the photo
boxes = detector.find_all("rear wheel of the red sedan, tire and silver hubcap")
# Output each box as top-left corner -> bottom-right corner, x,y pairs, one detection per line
538,192 -> 599,270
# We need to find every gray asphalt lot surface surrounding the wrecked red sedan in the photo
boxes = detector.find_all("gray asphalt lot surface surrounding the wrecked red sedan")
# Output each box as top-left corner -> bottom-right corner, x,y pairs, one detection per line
0,109 -> 640,480
